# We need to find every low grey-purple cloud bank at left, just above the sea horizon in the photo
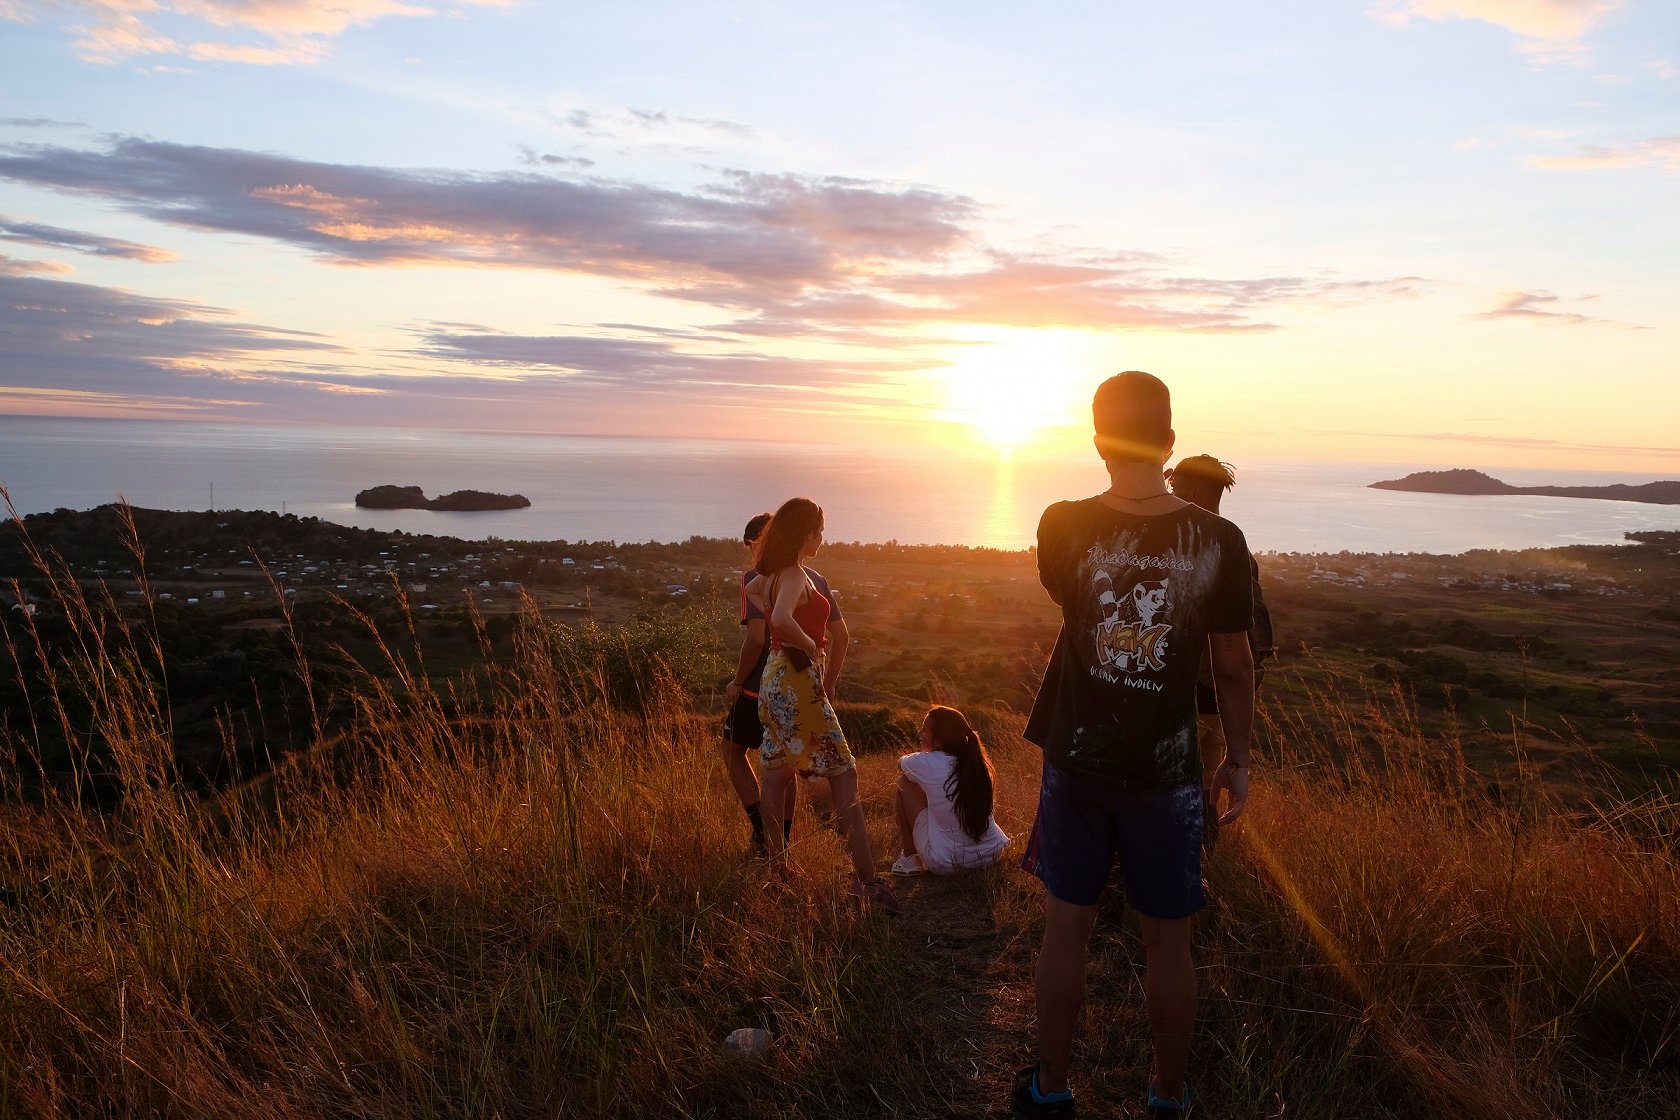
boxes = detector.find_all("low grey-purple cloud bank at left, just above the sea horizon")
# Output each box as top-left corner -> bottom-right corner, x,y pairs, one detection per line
0,268 -> 942,430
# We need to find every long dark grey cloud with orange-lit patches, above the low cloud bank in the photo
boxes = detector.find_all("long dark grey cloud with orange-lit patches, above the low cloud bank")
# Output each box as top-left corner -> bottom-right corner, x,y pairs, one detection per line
0,139 -> 978,290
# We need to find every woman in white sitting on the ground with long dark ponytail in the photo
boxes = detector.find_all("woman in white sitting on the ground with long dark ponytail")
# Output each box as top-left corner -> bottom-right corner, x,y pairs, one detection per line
892,707 -> 1010,875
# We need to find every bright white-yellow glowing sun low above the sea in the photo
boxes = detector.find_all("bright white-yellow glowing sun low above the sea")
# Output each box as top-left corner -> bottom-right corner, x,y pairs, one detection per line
942,331 -> 1102,453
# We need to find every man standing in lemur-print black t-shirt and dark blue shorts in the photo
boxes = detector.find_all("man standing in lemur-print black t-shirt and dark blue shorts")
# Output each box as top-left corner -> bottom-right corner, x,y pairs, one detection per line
1011,371 -> 1253,1118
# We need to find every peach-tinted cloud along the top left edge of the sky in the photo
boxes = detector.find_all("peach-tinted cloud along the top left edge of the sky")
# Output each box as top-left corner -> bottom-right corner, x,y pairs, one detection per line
0,0 -> 509,65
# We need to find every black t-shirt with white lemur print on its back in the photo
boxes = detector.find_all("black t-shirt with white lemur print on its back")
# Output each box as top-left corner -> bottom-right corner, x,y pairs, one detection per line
1026,497 -> 1253,793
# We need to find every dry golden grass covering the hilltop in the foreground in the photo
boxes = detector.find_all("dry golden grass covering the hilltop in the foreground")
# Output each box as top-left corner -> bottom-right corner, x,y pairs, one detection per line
0,520 -> 1680,1120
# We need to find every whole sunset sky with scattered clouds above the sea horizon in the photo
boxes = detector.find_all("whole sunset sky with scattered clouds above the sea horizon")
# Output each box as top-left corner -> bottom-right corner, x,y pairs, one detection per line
0,0 -> 1680,477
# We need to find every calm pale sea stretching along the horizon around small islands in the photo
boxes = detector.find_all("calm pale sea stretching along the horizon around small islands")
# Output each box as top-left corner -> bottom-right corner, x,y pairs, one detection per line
0,416 -> 1680,552
